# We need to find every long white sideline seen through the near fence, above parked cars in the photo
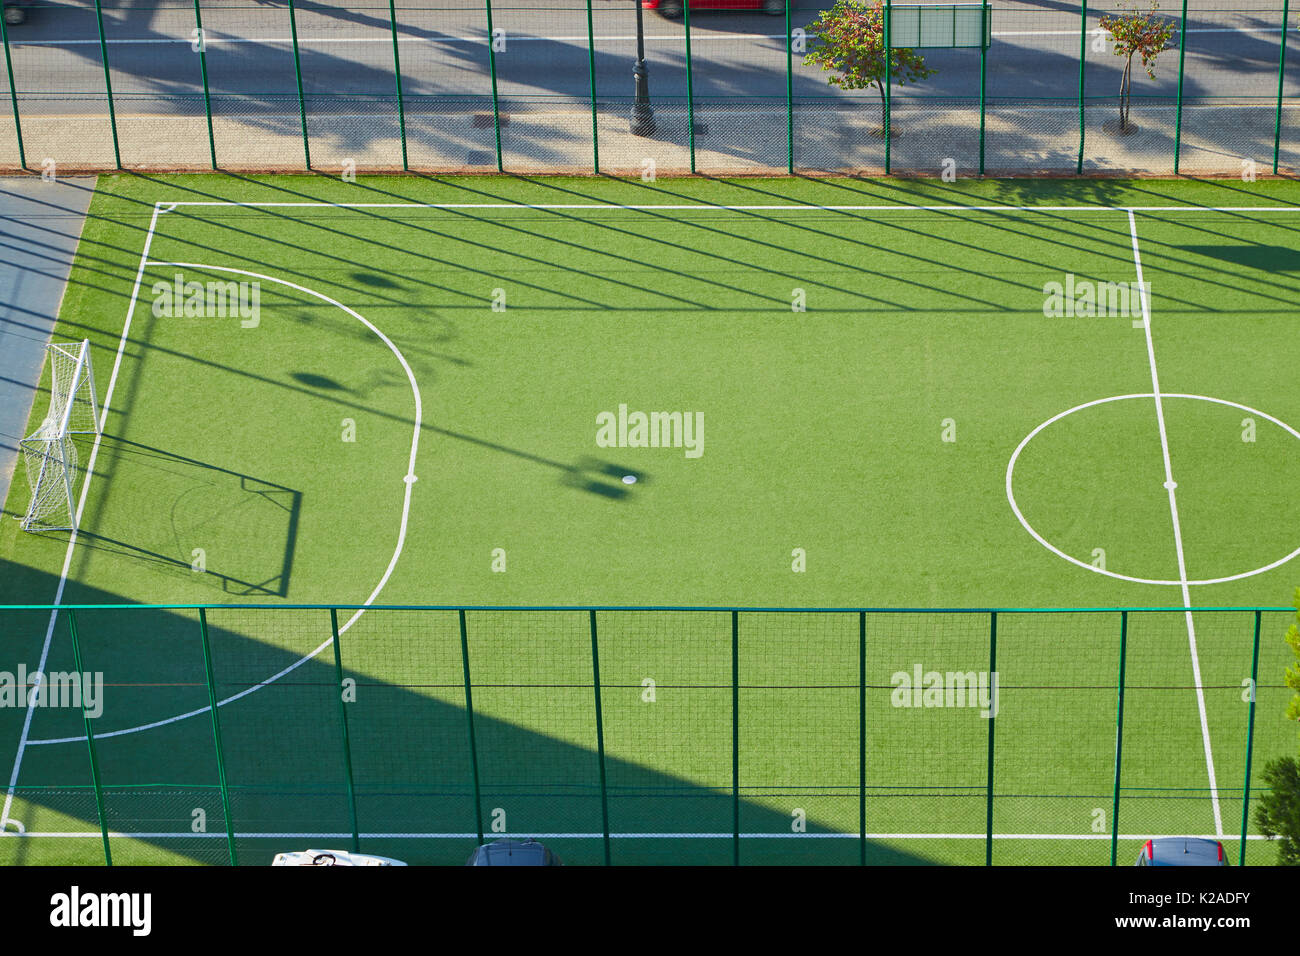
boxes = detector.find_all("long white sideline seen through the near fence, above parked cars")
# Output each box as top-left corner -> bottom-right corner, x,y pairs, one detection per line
3,830 -> 1266,842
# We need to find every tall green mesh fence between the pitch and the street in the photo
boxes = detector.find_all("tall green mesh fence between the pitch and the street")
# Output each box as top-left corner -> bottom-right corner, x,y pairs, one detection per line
0,0 -> 1300,178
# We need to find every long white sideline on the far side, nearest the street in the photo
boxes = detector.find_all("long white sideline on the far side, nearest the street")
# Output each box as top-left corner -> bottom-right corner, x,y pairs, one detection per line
152,199 -> 1300,212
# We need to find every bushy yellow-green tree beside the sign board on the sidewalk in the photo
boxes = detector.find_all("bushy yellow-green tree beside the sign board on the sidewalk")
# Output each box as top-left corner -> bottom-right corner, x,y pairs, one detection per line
803,0 -> 937,135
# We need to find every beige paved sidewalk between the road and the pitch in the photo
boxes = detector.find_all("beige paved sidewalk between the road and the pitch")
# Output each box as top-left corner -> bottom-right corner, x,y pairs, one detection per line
0,98 -> 1300,176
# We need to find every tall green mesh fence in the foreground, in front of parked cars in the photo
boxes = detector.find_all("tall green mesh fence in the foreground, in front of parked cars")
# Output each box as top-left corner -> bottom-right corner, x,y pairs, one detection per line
0,606 -> 1296,865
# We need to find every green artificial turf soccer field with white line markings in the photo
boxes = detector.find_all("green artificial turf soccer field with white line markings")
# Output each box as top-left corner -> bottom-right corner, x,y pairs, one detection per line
0,176 -> 1300,864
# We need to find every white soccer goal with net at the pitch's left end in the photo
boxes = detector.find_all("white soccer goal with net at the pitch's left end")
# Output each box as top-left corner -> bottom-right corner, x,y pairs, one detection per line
21,341 -> 99,532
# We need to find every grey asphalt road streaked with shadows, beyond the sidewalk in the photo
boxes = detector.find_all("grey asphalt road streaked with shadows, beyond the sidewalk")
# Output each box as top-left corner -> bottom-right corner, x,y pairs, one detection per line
0,0 -> 1300,113
